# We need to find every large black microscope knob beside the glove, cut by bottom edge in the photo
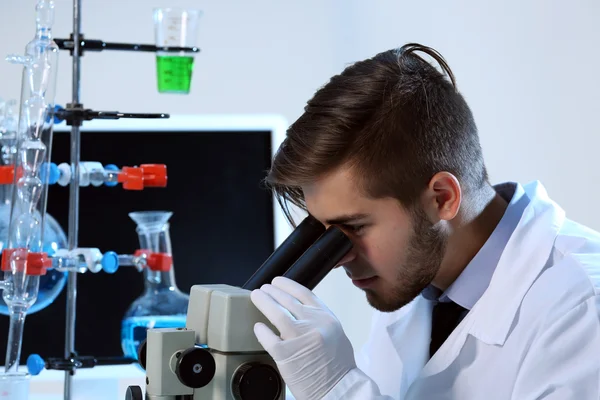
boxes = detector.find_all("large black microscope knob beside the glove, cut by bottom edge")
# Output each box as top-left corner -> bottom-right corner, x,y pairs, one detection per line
231,362 -> 283,400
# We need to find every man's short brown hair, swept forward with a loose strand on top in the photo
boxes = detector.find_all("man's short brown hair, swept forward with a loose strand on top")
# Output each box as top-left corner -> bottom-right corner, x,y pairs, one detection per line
266,43 -> 488,224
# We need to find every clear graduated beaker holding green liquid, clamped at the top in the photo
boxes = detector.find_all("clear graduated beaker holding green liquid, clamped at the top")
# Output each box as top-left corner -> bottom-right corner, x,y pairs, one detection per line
154,8 -> 202,94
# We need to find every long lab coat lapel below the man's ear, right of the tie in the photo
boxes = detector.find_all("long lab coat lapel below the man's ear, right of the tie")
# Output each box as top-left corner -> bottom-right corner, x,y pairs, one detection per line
419,182 -> 564,378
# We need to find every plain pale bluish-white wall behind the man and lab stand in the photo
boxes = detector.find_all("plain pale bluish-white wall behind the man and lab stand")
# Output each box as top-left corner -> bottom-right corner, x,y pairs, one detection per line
0,0 -> 600,354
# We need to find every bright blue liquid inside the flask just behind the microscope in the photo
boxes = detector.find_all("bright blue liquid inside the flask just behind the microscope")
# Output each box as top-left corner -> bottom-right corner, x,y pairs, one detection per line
121,314 -> 186,360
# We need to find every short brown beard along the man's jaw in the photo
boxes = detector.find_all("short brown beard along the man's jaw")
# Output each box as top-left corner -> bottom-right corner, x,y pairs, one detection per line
366,207 -> 446,312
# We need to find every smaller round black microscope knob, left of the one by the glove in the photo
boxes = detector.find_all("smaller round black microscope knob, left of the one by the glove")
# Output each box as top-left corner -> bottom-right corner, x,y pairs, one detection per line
175,347 -> 217,389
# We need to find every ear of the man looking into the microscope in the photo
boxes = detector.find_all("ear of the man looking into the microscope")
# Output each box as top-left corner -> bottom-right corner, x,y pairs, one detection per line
424,172 -> 462,223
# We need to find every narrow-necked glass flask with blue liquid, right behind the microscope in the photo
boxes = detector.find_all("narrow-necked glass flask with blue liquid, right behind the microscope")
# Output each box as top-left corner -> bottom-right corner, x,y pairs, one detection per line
121,211 -> 189,359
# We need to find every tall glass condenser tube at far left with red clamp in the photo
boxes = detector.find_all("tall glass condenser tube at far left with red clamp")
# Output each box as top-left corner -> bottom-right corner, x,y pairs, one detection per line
2,0 -> 59,373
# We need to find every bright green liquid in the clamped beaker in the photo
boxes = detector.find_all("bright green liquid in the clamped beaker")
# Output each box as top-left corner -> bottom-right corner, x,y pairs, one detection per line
156,56 -> 194,93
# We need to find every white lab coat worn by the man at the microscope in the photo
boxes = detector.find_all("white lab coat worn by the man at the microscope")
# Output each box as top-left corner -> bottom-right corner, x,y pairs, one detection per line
324,182 -> 600,400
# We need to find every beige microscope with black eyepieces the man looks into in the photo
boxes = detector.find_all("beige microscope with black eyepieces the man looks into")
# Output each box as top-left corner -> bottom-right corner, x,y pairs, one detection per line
125,215 -> 352,400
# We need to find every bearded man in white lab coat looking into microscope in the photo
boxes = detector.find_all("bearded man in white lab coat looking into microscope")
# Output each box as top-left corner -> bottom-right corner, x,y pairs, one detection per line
247,44 -> 600,400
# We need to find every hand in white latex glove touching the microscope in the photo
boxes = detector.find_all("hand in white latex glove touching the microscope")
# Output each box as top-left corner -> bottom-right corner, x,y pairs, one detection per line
251,277 -> 356,400
